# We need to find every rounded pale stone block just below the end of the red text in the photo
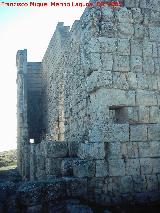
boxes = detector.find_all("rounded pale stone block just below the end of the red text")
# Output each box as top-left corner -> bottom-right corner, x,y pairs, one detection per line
115,7 -> 133,23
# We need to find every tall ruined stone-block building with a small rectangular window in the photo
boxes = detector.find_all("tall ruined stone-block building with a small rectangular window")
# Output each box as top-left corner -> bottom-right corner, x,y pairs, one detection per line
17,0 -> 160,206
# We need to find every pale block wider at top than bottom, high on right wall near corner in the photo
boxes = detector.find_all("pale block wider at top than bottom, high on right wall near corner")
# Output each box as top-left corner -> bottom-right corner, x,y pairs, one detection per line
98,37 -> 117,53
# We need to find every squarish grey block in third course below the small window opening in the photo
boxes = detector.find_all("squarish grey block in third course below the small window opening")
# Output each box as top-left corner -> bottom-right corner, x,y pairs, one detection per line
108,159 -> 125,176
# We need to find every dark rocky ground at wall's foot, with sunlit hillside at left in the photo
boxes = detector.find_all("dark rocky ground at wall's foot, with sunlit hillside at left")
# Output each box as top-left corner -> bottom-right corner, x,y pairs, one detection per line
0,151 -> 160,213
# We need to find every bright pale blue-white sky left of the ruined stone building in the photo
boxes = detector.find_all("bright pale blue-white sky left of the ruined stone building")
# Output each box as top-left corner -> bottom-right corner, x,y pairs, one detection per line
0,0 -> 85,151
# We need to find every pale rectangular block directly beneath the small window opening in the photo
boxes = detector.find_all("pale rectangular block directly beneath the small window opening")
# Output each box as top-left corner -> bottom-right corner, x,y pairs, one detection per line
103,124 -> 129,142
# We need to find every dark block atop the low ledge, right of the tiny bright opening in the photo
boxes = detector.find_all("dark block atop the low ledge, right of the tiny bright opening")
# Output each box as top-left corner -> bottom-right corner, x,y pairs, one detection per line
43,141 -> 68,158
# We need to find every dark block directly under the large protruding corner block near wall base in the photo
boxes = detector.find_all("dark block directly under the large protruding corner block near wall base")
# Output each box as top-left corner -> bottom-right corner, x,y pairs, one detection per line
73,160 -> 95,178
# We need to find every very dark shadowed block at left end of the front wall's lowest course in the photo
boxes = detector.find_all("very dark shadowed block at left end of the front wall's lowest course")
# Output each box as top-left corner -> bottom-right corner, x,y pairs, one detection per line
63,177 -> 87,197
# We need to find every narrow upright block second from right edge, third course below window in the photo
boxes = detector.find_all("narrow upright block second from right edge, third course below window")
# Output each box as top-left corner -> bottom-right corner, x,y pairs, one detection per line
140,158 -> 153,175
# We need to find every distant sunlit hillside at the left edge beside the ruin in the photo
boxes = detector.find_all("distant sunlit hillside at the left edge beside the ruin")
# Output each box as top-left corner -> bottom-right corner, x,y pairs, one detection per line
0,150 -> 17,168
